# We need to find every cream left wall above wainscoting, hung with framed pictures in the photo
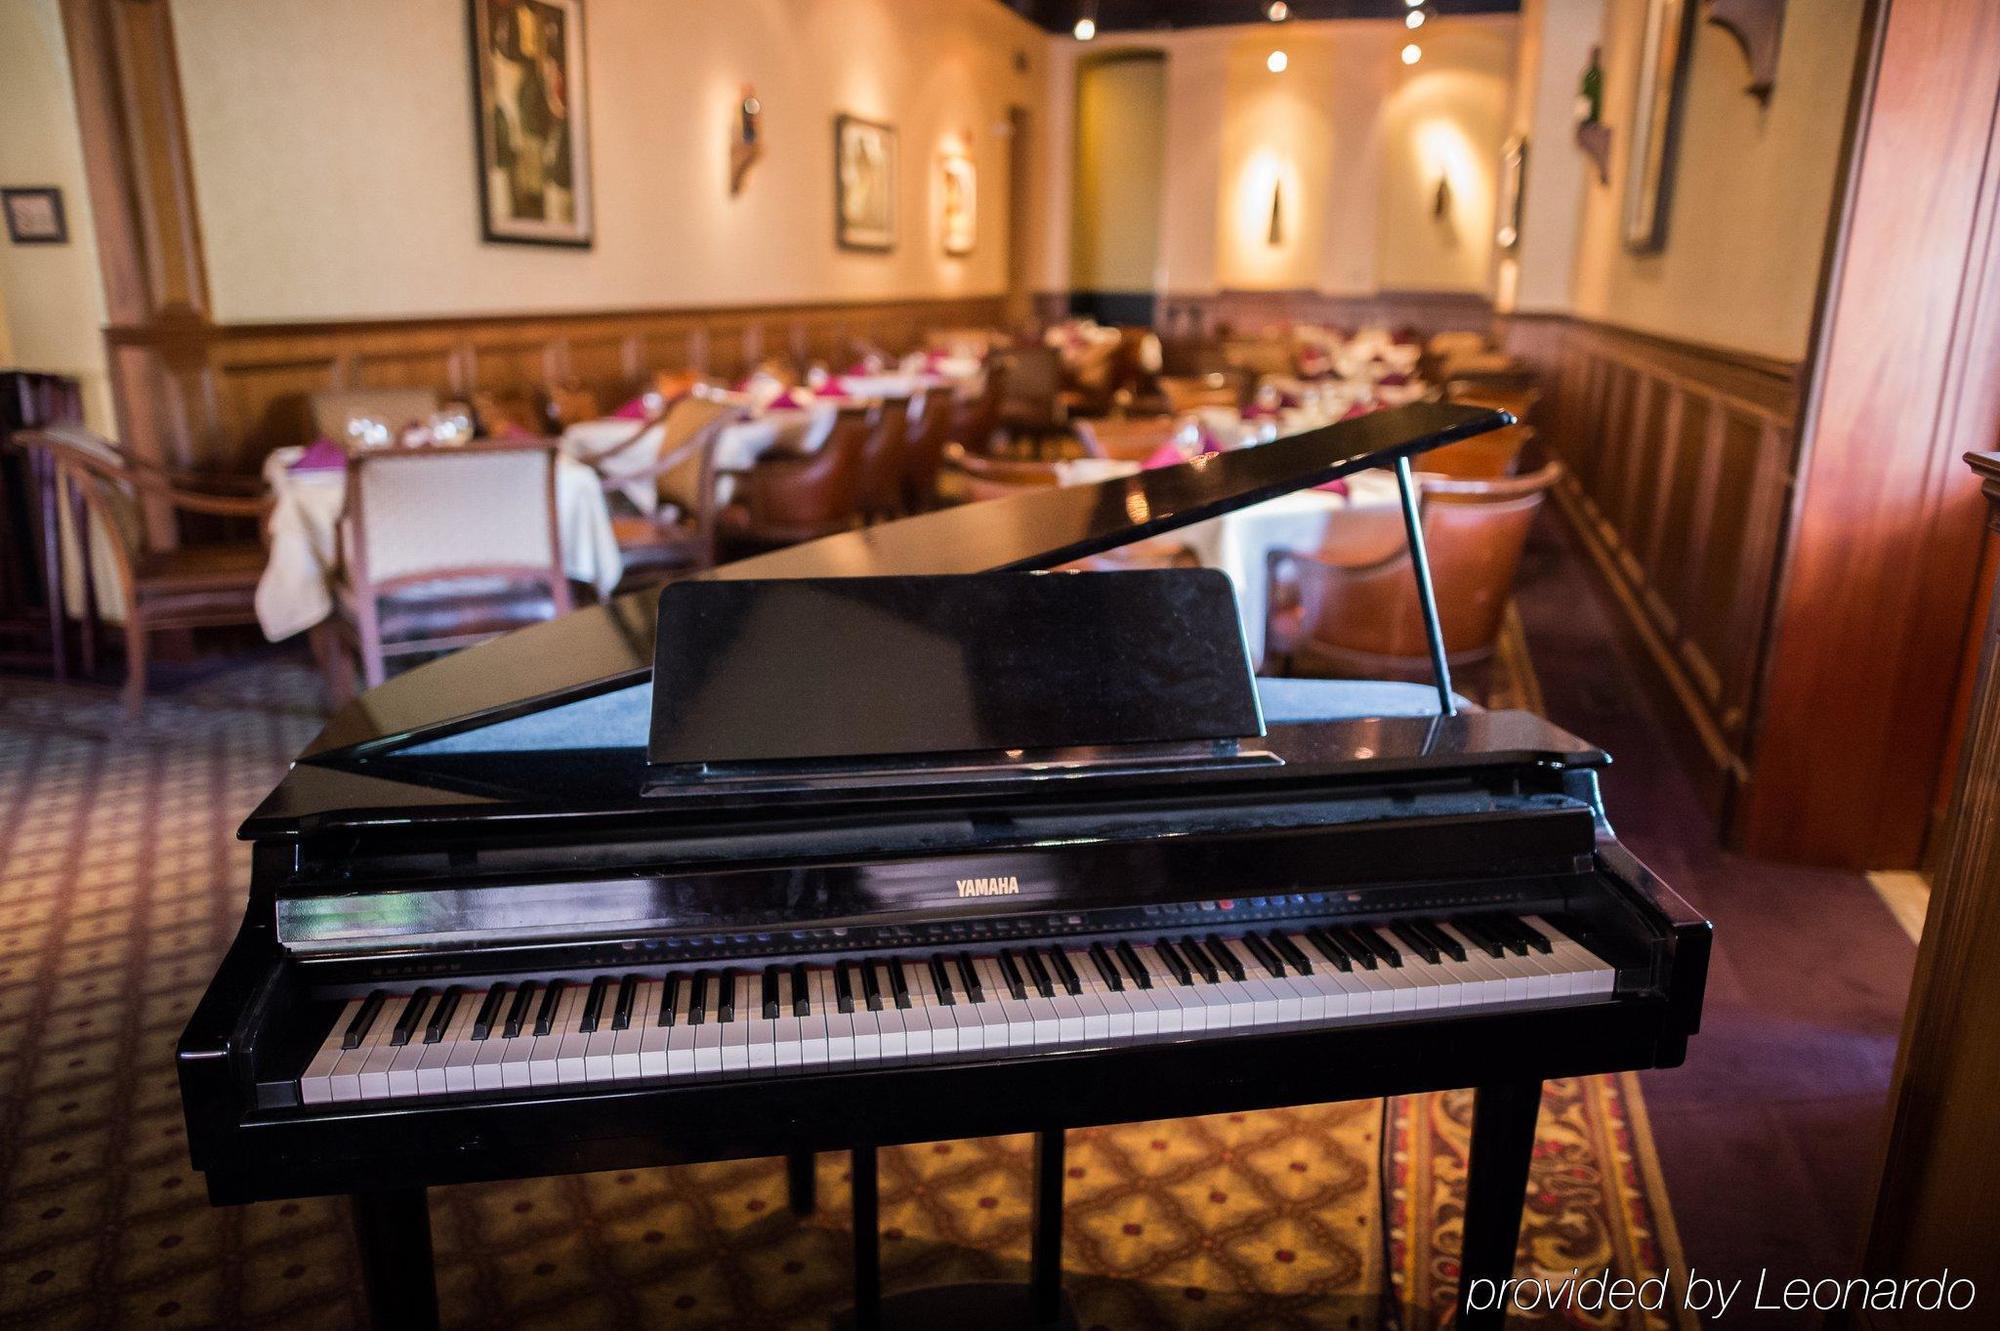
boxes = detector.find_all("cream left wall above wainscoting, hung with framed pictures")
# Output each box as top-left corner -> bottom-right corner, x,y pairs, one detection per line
170,0 -> 1066,322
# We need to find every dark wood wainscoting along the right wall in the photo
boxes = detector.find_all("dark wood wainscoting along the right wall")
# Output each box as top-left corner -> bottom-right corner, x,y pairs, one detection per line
1498,316 -> 1800,817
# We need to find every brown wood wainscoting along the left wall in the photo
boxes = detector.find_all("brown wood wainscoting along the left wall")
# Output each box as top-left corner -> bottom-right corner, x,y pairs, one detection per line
106,294 -> 1004,472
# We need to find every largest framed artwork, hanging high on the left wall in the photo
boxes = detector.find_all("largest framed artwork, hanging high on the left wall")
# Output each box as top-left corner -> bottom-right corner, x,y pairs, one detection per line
470,0 -> 594,246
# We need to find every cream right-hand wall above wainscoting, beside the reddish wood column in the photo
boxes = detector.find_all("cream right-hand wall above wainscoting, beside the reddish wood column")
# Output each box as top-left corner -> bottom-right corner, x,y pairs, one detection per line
1572,0 -> 1864,360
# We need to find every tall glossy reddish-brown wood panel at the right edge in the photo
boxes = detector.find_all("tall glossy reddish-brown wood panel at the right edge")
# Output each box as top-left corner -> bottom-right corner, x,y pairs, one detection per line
1738,0 -> 2000,867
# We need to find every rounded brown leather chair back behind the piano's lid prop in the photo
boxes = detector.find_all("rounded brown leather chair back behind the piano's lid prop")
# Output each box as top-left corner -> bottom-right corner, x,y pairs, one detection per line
1280,462 -> 1562,677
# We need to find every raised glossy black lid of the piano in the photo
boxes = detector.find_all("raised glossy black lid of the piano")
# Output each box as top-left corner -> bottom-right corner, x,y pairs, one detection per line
300,402 -> 1514,765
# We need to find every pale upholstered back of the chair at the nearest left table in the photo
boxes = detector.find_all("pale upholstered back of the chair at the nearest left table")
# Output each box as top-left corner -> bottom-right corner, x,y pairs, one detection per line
342,444 -> 568,591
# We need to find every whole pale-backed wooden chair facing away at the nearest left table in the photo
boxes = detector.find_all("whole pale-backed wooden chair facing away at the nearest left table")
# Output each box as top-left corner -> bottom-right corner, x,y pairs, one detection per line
322,444 -> 570,699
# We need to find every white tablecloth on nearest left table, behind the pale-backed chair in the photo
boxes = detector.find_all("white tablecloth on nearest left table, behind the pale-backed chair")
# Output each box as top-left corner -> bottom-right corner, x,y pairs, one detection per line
256,448 -> 624,642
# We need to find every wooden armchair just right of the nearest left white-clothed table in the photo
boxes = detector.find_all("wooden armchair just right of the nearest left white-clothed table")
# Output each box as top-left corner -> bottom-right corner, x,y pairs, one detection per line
584,398 -> 744,590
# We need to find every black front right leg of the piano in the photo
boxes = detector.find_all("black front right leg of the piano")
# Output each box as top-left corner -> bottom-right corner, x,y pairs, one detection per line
1458,1081 -> 1542,1331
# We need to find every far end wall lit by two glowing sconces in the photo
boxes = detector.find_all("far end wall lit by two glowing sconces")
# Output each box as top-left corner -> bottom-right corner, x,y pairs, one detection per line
1036,16 -> 1516,296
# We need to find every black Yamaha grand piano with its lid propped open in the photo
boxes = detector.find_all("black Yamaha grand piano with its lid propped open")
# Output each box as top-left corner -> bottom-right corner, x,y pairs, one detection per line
178,404 -> 1708,1327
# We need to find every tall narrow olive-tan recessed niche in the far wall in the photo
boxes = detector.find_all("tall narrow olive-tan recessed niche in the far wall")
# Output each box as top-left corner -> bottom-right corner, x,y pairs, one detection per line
1070,52 -> 1166,292
